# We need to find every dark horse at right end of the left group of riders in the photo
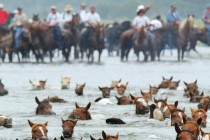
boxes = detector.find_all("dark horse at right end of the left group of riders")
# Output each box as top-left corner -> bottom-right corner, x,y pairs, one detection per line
79,24 -> 105,63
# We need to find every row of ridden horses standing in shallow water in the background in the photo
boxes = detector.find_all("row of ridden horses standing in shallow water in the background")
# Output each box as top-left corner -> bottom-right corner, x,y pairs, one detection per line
0,14 -> 207,62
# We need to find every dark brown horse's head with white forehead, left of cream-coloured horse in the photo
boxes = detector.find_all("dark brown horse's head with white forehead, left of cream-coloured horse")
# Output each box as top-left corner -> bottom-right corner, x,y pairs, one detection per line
135,97 -> 149,115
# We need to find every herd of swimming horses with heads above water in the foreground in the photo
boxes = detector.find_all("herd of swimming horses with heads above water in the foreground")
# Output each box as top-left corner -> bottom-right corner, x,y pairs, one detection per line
0,76 -> 210,140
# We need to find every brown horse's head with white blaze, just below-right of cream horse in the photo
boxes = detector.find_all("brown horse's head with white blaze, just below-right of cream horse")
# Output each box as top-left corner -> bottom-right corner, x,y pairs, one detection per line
171,108 -> 187,126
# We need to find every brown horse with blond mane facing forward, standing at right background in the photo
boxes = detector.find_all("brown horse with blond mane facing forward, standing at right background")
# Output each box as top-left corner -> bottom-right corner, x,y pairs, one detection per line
177,16 -> 194,61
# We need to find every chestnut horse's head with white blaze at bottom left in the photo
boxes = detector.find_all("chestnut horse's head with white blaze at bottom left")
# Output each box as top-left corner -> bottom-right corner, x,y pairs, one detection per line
28,120 -> 48,140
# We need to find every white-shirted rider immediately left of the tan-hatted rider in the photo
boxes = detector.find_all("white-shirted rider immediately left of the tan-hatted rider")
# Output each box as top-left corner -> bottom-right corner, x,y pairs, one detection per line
47,6 -> 61,48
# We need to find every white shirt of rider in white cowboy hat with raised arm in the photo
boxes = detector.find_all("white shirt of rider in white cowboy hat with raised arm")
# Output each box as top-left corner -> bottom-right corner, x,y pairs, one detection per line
133,16 -> 150,27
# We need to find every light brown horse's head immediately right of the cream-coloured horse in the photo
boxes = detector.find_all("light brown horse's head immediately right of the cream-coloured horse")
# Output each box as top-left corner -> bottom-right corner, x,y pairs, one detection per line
162,101 -> 179,118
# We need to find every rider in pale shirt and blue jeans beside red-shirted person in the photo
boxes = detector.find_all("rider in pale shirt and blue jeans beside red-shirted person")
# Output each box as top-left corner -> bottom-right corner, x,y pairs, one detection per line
14,7 -> 26,49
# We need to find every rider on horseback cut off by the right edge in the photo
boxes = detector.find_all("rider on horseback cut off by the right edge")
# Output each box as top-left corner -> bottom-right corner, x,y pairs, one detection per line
202,3 -> 210,45
